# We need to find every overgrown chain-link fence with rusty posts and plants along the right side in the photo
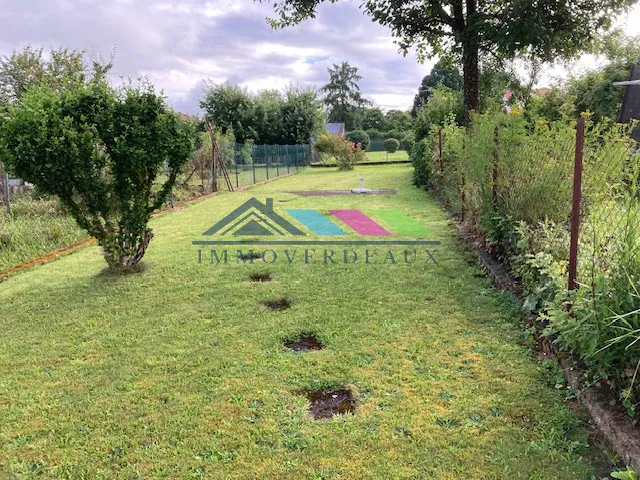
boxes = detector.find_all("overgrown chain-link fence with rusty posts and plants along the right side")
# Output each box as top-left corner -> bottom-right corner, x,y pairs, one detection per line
415,116 -> 640,408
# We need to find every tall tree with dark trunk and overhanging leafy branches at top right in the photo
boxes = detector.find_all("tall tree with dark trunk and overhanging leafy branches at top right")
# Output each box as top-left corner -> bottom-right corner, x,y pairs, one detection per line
257,0 -> 637,119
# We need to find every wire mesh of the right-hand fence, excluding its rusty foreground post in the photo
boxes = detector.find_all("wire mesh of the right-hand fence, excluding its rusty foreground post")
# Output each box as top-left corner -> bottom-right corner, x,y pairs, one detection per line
428,117 -> 640,293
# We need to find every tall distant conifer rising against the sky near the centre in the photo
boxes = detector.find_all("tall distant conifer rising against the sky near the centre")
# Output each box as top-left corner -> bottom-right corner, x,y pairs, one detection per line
320,62 -> 369,130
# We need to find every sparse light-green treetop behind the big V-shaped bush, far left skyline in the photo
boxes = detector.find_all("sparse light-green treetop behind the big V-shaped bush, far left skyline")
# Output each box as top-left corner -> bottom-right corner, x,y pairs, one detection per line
0,46 -> 94,106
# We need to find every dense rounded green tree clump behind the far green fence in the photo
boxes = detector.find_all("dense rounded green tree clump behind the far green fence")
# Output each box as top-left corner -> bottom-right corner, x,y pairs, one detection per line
200,84 -> 325,145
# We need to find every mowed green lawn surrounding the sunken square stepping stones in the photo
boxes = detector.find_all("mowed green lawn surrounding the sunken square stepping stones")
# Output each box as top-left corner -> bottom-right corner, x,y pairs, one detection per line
0,166 -> 592,480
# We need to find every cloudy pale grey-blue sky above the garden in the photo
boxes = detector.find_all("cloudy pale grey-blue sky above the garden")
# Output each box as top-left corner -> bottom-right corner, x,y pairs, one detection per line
0,0 -> 640,113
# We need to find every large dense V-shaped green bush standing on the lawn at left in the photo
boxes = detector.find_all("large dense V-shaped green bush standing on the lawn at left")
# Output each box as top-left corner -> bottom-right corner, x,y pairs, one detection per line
0,79 -> 194,272
